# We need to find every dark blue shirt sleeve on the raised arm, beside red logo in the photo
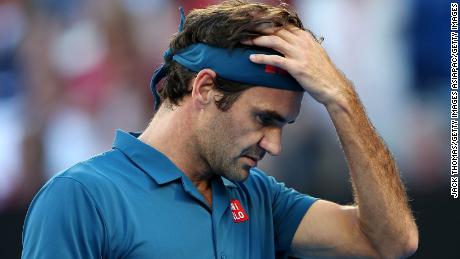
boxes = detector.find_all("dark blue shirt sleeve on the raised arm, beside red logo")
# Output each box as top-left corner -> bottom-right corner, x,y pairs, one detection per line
268,176 -> 318,256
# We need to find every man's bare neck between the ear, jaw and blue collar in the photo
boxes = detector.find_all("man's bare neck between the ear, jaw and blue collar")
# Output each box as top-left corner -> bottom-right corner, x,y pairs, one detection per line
139,104 -> 212,193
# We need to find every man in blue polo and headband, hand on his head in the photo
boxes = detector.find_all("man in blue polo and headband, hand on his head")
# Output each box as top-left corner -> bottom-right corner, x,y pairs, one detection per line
23,1 -> 418,258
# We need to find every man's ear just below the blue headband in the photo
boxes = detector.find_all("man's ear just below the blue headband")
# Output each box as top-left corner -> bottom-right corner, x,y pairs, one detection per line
192,68 -> 217,109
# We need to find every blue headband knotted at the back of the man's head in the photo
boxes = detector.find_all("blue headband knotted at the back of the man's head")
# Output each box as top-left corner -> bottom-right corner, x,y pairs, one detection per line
150,9 -> 304,110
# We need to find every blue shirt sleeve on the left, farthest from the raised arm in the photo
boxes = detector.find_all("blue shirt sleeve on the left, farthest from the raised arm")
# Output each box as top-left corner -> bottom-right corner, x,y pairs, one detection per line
22,177 -> 105,259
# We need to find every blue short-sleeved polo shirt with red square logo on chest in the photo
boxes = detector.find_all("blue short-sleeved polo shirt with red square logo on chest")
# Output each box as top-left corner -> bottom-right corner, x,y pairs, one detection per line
22,131 -> 316,259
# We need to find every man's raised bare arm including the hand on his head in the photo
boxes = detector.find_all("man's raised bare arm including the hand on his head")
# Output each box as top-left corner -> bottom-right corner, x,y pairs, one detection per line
243,28 -> 418,258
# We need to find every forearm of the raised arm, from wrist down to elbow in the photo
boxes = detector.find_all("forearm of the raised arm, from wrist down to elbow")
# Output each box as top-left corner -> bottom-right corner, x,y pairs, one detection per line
326,83 -> 418,258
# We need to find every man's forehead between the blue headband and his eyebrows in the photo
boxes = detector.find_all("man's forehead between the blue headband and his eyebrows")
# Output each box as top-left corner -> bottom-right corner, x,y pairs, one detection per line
234,86 -> 303,120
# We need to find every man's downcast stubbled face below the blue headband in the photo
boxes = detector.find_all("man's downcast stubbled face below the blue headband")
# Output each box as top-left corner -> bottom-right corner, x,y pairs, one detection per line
198,87 -> 303,181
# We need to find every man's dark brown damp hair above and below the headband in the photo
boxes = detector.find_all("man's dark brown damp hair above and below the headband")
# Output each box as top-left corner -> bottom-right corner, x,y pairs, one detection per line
159,0 -> 305,111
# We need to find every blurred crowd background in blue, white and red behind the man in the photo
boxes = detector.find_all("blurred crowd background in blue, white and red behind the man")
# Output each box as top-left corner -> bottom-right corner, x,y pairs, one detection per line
0,0 -> 452,258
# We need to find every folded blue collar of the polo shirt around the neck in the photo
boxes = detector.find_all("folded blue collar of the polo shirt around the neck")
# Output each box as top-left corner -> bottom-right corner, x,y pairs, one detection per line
113,130 -> 238,188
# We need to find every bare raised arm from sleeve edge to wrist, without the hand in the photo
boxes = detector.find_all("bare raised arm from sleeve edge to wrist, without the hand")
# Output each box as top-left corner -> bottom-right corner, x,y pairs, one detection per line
293,80 -> 418,258
